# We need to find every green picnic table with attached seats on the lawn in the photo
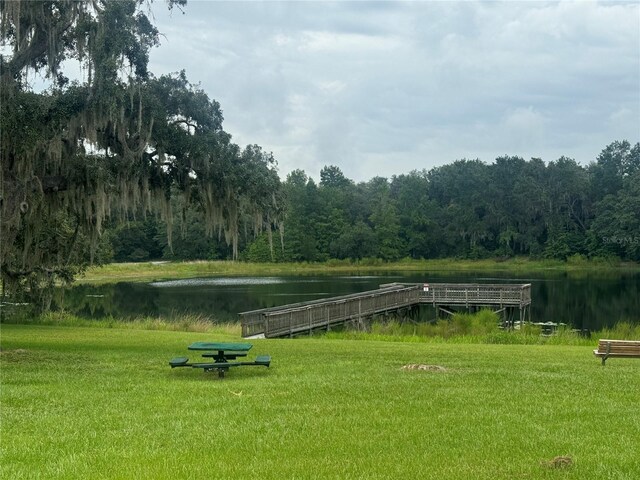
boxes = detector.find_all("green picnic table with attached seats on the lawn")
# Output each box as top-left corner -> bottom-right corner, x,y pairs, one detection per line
169,342 -> 271,378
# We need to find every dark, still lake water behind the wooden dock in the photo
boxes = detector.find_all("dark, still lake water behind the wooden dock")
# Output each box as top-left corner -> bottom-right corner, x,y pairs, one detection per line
55,272 -> 640,330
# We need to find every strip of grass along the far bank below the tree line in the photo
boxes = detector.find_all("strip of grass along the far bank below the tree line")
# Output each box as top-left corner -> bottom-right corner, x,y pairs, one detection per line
78,258 -> 640,283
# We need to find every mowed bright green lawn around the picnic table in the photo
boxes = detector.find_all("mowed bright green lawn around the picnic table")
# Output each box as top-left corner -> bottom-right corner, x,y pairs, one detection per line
0,325 -> 640,479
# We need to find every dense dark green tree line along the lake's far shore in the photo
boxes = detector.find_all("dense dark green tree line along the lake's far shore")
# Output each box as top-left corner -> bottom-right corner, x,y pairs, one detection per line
106,140 -> 640,262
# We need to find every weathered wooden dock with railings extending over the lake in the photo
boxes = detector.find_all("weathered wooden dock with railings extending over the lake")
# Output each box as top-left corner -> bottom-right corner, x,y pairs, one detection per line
240,283 -> 531,338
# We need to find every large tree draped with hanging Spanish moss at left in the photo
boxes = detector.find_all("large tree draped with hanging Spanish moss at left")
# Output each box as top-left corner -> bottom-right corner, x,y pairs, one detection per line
0,0 -> 282,306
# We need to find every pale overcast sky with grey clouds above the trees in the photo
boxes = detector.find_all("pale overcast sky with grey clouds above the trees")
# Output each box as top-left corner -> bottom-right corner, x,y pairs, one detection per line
150,0 -> 640,181
